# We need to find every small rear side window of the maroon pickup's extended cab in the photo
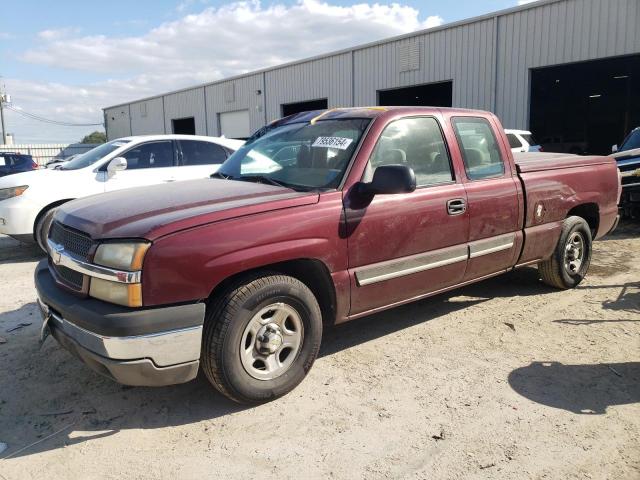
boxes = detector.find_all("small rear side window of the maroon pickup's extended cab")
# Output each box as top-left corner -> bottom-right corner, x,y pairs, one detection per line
452,117 -> 504,180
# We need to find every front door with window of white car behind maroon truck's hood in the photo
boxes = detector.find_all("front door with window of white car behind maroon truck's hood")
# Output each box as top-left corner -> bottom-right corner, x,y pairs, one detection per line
104,140 -> 177,192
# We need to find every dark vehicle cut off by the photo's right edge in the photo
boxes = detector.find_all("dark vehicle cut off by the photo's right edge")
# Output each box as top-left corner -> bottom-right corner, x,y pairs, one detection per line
611,127 -> 640,218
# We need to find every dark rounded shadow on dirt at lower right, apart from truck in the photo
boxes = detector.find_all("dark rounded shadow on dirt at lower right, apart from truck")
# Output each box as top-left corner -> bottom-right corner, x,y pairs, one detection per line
509,362 -> 640,415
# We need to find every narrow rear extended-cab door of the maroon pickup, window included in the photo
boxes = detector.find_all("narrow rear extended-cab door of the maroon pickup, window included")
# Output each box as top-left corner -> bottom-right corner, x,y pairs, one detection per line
451,116 -> 522,281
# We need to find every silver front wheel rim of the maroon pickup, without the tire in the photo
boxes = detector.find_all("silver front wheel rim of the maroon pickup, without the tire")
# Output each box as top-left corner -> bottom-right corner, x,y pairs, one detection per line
240,303 -> 304,380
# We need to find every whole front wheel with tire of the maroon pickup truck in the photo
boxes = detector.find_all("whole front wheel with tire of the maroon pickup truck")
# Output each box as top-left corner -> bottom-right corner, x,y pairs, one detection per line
201,273 -> 322,404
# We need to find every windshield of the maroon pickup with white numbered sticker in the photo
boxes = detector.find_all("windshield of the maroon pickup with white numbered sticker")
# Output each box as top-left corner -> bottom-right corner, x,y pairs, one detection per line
216,118 -> 370,190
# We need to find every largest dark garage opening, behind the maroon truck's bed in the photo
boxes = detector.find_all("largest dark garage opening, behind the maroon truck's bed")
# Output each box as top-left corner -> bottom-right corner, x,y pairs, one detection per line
529,55 -> 640,155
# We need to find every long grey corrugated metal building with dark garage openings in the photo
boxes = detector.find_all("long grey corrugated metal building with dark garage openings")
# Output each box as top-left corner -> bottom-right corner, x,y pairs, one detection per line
104,0 -> 640,153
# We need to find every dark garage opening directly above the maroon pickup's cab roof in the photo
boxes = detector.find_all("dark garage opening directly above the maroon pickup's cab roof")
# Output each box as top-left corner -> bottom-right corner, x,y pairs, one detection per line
378,81 -> 453,107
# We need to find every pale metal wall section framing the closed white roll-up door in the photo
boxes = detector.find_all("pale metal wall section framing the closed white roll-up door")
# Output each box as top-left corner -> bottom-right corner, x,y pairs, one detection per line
205,74 -> 265,136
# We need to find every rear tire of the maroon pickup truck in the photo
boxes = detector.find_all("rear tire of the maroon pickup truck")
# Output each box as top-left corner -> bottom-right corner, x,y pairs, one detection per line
538,217 -> 593,290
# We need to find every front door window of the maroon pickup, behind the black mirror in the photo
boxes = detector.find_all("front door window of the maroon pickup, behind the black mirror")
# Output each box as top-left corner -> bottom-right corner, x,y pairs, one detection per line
364,117 -> 454,187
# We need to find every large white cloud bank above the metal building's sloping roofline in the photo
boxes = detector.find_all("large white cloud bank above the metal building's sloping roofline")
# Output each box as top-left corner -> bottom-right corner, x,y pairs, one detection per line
7,0 -> 443,142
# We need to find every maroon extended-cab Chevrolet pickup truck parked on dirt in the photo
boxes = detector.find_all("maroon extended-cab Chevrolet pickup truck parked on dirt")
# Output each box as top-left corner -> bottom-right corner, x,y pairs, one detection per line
35,107 -> 620,403
